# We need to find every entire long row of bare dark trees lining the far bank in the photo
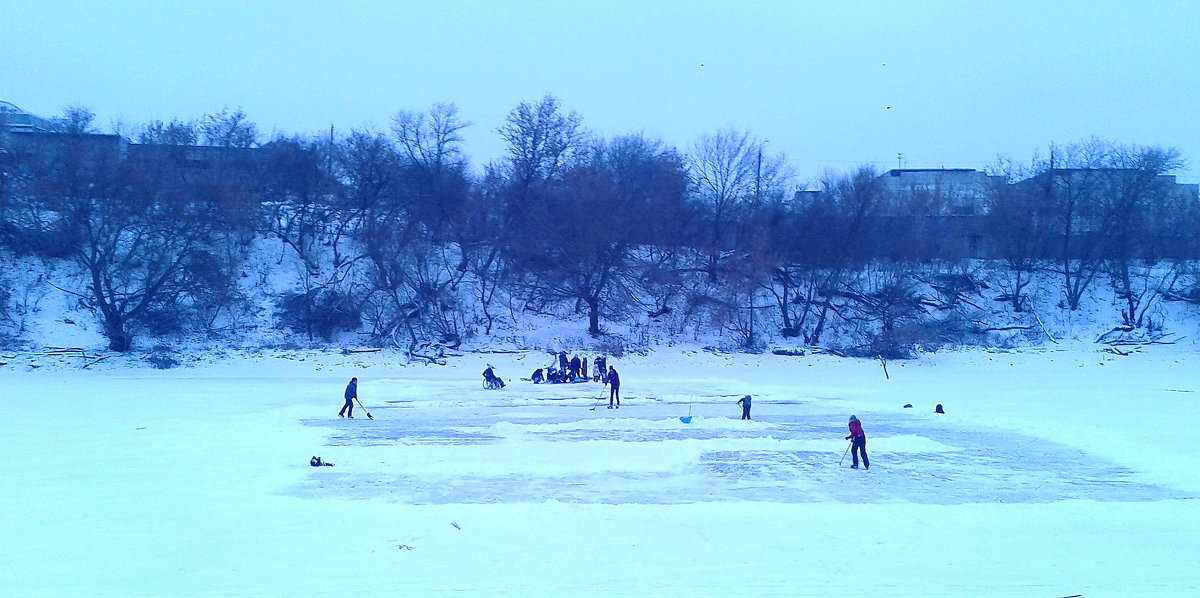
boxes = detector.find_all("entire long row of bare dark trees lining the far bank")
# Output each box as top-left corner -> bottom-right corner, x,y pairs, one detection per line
0,96 -> 1198,351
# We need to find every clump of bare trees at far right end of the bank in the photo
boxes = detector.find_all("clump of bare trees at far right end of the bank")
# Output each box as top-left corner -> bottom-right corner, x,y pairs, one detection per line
989,139 -> 1200,327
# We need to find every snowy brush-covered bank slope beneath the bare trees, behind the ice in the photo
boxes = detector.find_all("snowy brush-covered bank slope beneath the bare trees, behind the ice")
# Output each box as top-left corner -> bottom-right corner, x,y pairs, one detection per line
0,234 -> 1200,367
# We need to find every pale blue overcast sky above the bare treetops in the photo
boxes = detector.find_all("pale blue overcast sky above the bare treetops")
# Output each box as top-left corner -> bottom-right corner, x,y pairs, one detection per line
0,0 -> 1200,181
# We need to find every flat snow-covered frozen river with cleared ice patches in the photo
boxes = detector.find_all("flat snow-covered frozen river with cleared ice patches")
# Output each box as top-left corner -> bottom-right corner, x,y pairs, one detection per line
0,345 -> 1200,598
